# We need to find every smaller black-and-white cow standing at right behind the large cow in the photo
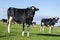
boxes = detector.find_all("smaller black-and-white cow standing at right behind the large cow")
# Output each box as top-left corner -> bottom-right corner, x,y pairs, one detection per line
40,17 -> 59,33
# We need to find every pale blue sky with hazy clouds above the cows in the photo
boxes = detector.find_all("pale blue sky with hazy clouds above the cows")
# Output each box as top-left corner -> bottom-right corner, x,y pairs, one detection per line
0,0 -> 60,25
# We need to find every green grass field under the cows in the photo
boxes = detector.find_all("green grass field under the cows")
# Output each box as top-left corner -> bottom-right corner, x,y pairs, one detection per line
0,22 -> 60,40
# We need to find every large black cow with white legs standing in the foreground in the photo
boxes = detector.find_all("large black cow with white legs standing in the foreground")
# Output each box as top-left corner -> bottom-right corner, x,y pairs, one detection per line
7,6 -> 39,36
